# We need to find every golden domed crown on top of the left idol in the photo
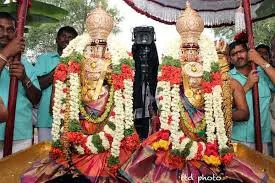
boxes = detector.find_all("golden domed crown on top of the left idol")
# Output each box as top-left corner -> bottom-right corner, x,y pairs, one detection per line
86,3 -> 114,41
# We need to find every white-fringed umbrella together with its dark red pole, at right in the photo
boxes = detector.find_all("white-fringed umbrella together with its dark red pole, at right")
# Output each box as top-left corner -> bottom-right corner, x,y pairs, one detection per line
124,0 -> 275,152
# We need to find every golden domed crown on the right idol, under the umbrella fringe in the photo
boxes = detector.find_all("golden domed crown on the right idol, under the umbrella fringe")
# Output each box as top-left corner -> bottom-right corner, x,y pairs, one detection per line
176,1 -> 204,44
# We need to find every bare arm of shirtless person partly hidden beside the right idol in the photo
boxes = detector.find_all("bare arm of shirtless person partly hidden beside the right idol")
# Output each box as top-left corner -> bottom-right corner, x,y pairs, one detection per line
231,79 -> 249,122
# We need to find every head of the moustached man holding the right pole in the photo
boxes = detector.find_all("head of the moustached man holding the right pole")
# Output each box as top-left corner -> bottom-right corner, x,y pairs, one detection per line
229,41 -> 248,68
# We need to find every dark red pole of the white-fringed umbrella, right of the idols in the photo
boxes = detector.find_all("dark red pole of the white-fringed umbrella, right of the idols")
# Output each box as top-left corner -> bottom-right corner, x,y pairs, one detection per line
243,0 -> 263,152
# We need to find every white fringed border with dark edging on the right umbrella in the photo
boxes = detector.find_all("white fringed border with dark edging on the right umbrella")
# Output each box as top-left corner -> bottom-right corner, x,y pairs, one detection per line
124,0 -> 275,27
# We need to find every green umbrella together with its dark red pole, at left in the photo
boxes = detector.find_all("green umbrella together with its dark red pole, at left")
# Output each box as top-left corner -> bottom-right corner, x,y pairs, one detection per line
0,0 -> 68,156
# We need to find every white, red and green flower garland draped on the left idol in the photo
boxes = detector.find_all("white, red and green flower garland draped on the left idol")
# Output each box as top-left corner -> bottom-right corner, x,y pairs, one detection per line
52,34 -> 138,166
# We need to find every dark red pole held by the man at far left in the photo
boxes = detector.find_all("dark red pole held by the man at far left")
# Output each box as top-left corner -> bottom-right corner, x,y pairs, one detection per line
3,0 -> 29,157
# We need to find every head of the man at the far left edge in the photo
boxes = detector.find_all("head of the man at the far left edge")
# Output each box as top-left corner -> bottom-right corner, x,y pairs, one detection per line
0,12 -> 16,49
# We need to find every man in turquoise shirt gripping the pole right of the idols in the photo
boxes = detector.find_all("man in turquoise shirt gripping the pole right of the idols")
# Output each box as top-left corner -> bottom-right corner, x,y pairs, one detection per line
229,41 -> 275,154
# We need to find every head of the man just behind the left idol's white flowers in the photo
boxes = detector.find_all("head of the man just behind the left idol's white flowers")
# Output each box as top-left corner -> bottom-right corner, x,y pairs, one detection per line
56,26 -> 78,54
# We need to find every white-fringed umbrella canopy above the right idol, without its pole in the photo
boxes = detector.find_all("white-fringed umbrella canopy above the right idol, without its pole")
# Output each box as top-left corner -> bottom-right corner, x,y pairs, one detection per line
124,0 -> 275,27
